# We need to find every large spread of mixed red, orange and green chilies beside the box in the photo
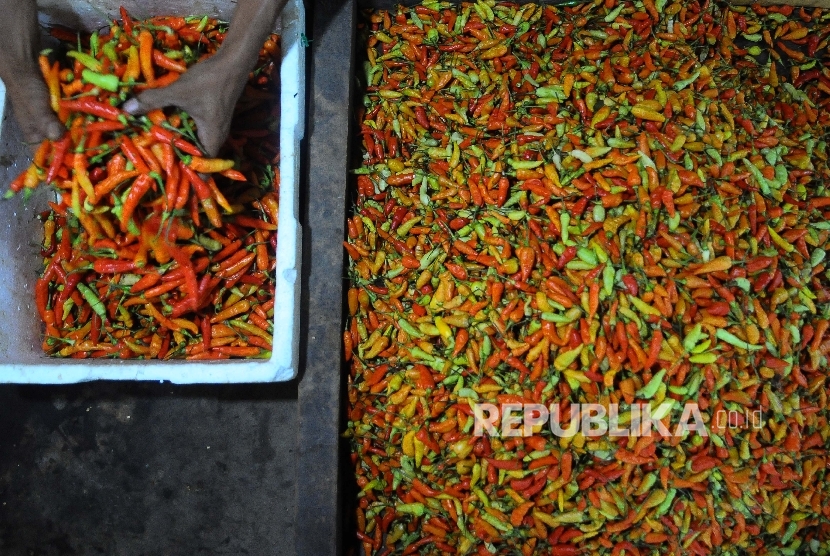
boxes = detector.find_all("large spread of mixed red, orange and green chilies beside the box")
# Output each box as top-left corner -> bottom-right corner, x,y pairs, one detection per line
343,0 -> 830,556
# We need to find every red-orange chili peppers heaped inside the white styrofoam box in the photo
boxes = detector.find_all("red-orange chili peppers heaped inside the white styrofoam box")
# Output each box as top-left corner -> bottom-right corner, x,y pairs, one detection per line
9,9 -> 279,359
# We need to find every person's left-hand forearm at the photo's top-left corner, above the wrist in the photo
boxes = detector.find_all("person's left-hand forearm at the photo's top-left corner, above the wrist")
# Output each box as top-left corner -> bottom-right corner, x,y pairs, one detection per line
0,0 -> 40,80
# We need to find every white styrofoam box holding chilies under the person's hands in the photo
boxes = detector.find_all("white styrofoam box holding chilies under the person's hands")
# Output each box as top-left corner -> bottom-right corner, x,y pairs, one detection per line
0,0 -> 305,384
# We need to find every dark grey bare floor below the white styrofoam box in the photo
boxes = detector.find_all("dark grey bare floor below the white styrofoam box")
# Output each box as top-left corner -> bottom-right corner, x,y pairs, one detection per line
0,382 -> 298,556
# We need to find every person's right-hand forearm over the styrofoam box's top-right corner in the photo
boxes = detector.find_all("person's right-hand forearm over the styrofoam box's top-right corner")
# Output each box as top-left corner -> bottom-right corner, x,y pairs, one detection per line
218,0 -> 287,73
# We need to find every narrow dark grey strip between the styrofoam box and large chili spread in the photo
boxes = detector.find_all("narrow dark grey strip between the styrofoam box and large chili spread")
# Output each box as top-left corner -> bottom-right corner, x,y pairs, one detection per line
297,0 -> 355,556
